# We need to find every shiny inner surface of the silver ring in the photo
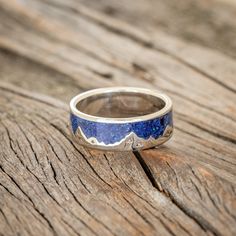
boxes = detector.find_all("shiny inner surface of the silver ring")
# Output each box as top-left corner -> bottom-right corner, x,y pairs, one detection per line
76,92 -> 165,118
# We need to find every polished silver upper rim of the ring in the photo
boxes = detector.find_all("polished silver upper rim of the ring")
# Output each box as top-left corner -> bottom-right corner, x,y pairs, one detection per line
70,87 -> 172,123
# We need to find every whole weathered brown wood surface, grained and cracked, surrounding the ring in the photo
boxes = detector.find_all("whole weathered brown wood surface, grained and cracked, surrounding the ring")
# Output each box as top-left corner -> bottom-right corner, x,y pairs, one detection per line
0,0 -> 236,235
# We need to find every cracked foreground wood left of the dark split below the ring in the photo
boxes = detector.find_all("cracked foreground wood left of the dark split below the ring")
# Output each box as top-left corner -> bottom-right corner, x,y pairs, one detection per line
0,85 -> 212,235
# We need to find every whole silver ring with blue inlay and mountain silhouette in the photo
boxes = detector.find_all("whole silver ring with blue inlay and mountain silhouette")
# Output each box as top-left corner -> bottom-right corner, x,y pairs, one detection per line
70,87 -> 173,151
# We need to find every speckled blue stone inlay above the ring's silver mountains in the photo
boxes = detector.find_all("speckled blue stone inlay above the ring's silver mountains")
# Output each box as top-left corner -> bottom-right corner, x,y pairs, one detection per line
70,112 -> 173,144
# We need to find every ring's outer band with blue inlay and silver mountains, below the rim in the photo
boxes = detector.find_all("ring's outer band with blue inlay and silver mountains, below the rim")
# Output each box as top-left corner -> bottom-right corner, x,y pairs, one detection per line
70,111 -> 173,150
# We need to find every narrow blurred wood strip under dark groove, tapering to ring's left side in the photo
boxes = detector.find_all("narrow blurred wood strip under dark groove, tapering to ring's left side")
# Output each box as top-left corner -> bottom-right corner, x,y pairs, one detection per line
0,49 -> 86,102
